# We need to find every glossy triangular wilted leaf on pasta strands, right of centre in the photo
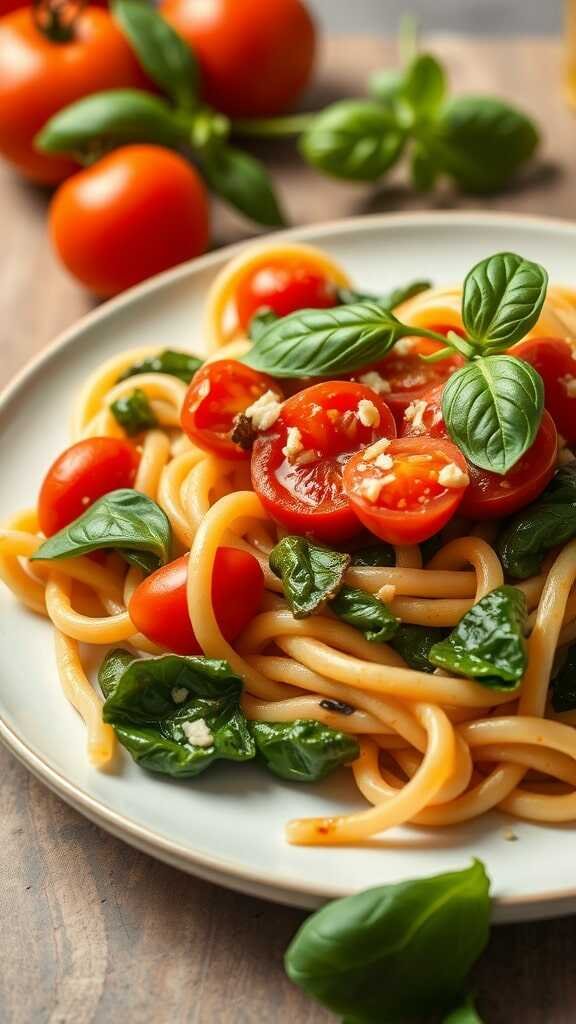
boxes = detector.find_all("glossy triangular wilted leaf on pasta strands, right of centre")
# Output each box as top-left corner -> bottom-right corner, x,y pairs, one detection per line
428,586 -> 528,690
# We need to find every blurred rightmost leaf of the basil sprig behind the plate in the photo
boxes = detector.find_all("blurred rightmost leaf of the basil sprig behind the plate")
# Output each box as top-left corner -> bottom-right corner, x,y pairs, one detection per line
425,96 -> 539,193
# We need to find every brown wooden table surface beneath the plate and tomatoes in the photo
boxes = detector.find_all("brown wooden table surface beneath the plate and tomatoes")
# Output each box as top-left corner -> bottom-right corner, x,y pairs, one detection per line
0,37 -> 576,1024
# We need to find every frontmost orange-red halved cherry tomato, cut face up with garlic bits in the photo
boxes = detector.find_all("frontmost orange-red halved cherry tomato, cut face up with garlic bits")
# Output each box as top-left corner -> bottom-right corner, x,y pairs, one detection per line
343,437 -> 468,544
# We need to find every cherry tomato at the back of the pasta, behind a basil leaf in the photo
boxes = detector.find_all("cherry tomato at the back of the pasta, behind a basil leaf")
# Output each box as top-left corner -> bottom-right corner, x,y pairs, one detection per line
236,258 -> 337,330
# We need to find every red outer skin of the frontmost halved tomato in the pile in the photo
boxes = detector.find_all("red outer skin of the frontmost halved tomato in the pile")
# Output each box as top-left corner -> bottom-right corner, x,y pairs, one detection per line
343,437 -> 466,545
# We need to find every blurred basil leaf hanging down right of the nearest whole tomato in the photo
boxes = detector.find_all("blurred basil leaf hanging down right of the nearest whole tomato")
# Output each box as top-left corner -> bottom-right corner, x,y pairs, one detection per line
199,144 -> 286,227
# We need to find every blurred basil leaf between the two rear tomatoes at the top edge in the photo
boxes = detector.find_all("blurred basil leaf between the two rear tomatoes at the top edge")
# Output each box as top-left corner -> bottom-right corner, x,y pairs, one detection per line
112,0 -> 200,110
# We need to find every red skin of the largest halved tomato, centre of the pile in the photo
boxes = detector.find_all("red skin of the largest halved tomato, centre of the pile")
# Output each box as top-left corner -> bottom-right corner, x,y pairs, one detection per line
251,381 -> 396,544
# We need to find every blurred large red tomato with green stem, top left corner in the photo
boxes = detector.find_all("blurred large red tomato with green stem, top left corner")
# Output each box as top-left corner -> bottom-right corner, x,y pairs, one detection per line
0,7 -> 147,184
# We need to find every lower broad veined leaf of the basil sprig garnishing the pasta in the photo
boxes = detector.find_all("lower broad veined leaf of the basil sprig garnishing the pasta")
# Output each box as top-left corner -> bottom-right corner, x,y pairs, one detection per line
442,355 -> 544,475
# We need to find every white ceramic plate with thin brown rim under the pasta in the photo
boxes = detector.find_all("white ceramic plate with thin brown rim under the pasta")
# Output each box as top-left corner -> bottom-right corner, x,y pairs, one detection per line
0,213 -> 576,921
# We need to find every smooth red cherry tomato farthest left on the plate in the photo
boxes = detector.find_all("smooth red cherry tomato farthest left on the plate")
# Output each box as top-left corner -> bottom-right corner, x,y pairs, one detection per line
38,437 -> 139,537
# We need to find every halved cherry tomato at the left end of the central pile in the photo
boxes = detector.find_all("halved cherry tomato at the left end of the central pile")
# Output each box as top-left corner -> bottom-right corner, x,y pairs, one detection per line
181,359 -> 283,459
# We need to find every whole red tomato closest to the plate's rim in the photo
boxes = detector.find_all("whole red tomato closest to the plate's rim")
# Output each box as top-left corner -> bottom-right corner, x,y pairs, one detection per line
49,145 -> 209,296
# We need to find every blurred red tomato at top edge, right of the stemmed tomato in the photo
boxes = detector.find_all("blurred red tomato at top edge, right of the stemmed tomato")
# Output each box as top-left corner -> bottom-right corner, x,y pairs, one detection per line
160,0 -> 316,117
